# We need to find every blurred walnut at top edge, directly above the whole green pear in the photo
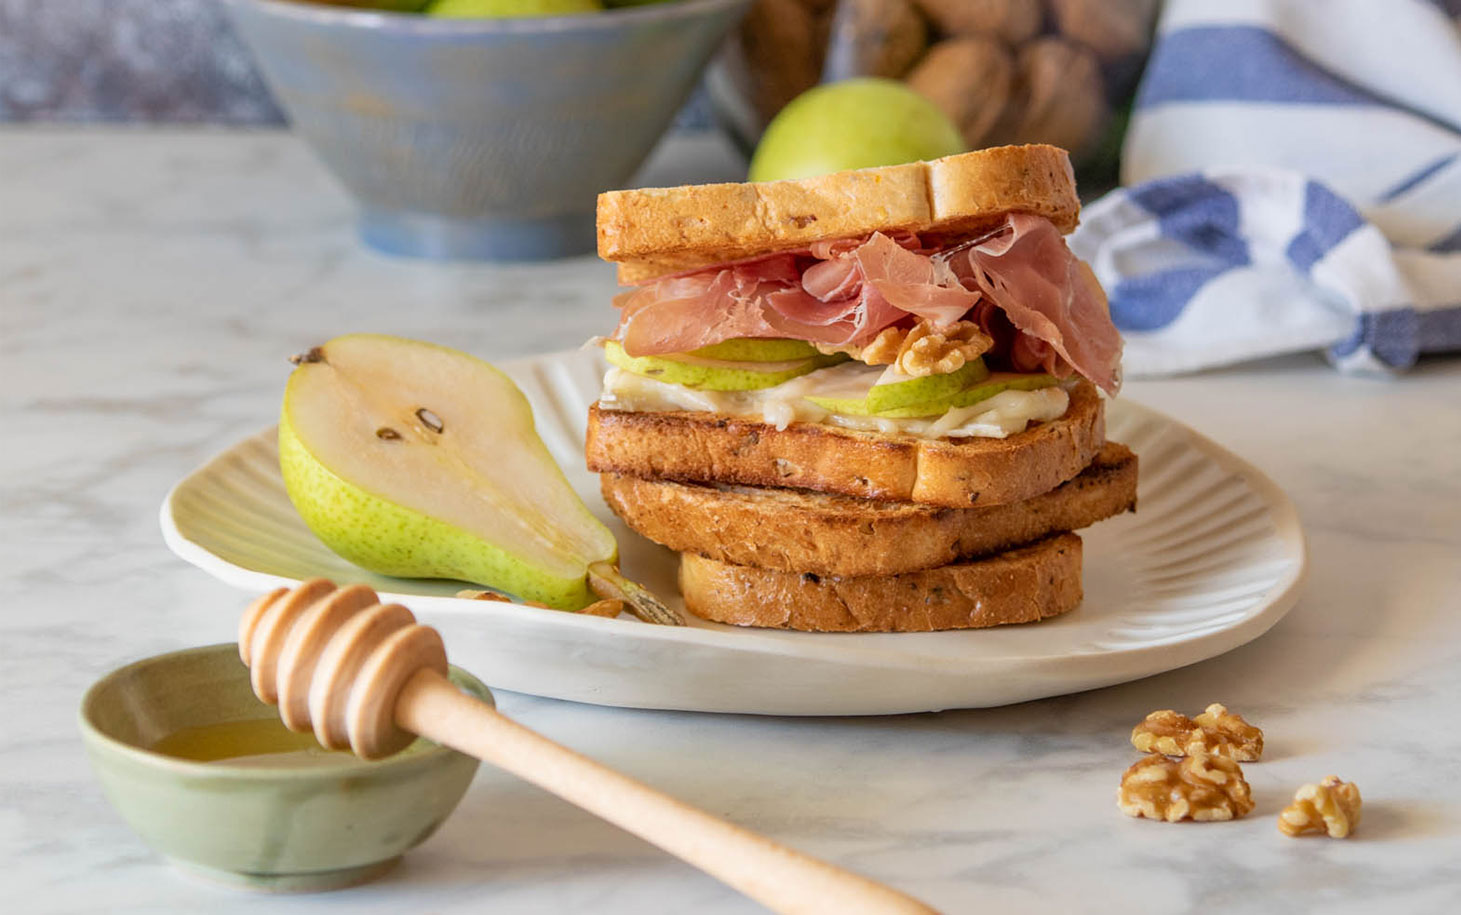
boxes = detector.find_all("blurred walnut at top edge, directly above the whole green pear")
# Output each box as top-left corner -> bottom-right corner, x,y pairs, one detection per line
823,0 -> 928,80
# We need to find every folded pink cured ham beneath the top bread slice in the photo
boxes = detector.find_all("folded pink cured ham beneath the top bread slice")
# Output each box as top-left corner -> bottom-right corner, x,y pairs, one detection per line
614,215 -> 1121,393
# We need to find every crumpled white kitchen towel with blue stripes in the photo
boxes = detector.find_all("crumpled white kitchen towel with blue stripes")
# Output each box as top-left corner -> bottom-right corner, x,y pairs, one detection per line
1071,0 -> 1461,376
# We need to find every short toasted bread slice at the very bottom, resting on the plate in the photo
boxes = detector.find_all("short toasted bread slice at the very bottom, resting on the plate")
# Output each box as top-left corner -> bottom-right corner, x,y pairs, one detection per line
679,534 -> 1081,633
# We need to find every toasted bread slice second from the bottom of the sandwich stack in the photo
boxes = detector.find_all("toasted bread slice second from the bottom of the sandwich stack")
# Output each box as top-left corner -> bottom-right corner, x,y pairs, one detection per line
600,441 -> 1137,576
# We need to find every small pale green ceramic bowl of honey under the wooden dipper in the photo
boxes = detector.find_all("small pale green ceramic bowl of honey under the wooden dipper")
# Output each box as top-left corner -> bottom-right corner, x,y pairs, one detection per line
80,643 -> 492,892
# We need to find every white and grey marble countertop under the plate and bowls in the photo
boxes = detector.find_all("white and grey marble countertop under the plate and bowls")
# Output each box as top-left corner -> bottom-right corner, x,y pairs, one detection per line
0,130 -> 1461,915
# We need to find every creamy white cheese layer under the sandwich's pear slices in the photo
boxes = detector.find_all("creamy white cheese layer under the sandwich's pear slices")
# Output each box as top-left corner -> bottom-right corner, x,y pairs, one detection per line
599,362 -> 1069,438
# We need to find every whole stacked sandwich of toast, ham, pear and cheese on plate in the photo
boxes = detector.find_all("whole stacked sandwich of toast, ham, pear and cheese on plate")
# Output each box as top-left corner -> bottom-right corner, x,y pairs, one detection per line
586,146 -> 1137,631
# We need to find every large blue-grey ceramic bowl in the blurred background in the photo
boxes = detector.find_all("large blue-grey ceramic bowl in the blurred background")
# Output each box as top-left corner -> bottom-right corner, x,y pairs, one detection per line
226,0 -> 749,260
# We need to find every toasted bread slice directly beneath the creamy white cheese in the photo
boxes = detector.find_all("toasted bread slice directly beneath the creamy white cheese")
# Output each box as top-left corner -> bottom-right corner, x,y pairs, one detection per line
584,381 -> 1106,509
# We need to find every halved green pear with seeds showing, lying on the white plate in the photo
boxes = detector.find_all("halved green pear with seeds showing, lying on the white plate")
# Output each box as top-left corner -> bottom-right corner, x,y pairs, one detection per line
279,333 -> 682,623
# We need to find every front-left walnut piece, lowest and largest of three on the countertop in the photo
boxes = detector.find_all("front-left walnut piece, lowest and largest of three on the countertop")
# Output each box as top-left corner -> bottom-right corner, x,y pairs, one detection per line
1116,753 -> 1254,823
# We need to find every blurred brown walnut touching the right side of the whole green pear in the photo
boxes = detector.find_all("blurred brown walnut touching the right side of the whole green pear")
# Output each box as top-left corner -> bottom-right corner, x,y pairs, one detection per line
907,38 -> 1014,149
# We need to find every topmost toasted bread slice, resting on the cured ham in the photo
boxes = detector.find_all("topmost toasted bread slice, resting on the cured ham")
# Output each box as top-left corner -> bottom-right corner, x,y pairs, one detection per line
598,145 -> 1081,285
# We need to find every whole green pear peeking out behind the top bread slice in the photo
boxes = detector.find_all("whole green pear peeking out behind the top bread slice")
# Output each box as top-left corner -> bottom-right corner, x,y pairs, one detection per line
749,77 -> 964,181
